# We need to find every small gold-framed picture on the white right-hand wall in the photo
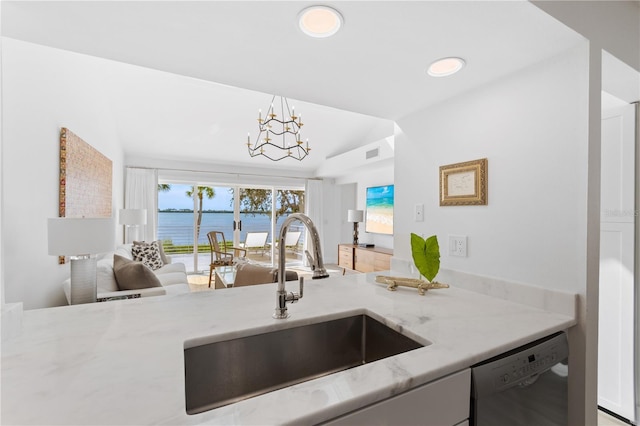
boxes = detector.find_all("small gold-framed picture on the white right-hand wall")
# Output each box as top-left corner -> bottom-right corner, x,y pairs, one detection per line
440,158 -> 488,206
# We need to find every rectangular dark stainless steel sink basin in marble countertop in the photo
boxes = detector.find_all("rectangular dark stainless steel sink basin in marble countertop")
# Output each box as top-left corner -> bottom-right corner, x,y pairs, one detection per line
184,315 -> 424,414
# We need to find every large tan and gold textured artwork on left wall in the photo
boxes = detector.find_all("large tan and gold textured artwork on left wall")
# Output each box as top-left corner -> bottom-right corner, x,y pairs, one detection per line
58,127 -> 113,264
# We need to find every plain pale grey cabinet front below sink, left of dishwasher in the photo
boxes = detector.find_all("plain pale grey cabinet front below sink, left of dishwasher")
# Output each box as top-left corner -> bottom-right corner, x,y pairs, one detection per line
326,369 -> 471,426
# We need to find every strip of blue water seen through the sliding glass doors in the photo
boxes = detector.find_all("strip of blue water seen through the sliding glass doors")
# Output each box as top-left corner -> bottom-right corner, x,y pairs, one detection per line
158,212 -> 303,245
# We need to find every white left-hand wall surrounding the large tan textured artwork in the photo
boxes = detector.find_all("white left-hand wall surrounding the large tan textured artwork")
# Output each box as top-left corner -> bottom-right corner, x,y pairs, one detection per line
2,38 -> 123,309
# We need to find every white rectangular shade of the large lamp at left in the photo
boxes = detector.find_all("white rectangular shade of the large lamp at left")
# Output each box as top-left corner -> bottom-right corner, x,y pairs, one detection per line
48,217 -> 116,256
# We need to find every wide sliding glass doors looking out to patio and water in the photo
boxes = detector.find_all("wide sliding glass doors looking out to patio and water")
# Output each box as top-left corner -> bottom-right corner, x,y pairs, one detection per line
158,181 -> 305,273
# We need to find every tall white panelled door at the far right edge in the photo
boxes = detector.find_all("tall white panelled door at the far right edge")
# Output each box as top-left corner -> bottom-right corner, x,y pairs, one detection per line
598,105 -> 635,422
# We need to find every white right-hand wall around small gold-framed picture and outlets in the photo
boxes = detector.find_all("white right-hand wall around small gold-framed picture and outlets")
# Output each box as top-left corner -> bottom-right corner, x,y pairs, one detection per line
394,43 -> 599,424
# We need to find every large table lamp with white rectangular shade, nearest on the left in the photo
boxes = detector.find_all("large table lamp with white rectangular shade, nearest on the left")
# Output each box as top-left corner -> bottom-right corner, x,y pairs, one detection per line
47,217 -> 115,305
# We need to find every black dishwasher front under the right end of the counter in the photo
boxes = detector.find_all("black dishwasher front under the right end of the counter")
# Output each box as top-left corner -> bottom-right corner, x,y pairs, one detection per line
471,332 -> 569,426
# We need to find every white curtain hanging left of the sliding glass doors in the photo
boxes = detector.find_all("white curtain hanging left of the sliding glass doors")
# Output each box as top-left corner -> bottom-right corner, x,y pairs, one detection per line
124,167 -> 158,241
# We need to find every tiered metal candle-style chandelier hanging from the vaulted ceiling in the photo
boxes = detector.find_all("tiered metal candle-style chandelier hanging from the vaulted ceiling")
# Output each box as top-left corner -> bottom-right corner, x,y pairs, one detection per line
247,95 -> 311,161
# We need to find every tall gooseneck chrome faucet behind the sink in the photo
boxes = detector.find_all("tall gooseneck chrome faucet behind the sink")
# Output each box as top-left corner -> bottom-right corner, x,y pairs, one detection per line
273,213 -> 329,319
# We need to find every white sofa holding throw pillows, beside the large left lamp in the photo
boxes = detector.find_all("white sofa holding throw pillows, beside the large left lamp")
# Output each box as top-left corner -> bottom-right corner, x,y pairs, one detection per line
63,244 -> 189,303
